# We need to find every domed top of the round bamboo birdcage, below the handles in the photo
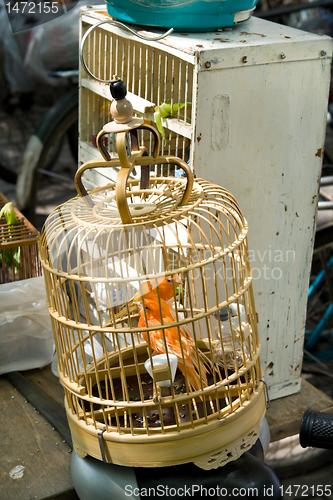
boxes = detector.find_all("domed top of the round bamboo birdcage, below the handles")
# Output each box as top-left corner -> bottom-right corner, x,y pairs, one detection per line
41,177 -> 248,280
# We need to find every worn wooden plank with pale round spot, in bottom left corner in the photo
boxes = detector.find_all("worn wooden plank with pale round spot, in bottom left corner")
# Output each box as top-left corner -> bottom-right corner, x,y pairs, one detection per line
0,376 -> 77,500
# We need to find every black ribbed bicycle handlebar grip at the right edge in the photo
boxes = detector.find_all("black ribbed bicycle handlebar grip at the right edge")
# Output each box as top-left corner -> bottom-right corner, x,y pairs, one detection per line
299,410 -> 333,450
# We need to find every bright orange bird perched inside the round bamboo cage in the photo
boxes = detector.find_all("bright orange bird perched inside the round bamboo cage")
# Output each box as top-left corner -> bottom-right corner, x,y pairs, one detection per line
136,292 -> 208,391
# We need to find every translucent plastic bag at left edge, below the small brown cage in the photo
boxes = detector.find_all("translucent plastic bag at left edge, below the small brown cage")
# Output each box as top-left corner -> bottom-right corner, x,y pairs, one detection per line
0,276 -> 54,374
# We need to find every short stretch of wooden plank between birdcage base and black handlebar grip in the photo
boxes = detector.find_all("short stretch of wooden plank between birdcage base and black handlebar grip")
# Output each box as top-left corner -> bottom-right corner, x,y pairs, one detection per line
266,379 -> 333,442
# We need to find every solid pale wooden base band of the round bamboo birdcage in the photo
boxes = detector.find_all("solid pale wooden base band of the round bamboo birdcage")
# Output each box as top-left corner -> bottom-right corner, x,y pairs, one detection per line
66,382 -> 266,470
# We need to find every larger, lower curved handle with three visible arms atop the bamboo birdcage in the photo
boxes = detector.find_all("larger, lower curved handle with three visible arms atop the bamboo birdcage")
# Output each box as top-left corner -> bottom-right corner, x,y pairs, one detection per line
74,152 -> 194,224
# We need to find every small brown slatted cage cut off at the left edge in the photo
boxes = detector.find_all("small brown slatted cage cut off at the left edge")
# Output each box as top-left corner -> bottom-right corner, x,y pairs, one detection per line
0,193 -> 42,283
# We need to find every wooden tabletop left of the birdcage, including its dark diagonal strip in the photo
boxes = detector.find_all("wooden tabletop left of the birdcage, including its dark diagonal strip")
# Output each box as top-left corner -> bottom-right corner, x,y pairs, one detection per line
0,367 -> 78,500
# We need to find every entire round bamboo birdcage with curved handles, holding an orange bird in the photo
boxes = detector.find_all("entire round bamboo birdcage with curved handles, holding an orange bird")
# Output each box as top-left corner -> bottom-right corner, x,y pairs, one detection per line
39,78 -> 266,469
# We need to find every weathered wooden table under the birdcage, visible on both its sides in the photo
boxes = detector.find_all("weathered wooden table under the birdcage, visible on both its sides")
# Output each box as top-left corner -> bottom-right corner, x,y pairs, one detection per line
0,366 -> 333,500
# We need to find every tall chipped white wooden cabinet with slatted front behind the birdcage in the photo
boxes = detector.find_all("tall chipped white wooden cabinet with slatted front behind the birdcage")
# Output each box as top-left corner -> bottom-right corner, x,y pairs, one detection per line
80,7 -> 332,399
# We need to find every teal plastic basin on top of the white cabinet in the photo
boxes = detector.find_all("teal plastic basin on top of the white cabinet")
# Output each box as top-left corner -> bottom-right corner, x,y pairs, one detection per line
106,0 -> 258,32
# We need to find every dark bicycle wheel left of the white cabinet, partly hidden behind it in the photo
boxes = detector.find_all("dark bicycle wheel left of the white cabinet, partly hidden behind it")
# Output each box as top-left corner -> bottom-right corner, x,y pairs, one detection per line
16,88 -> 78,226
